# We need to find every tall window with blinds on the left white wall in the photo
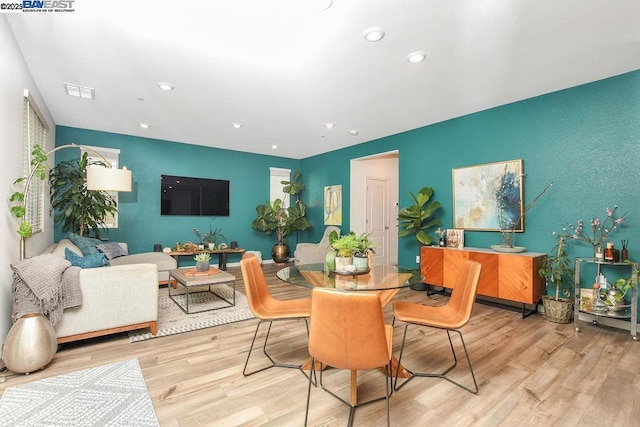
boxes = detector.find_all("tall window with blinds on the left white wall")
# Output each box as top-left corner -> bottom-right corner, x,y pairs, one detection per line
22,89 -> 49,234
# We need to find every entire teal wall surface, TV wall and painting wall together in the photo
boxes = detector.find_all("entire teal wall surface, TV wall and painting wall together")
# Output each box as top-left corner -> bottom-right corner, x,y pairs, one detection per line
56,71 -> 640,310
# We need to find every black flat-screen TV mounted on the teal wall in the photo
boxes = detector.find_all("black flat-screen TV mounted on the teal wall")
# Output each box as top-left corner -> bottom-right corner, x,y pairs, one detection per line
160,175 -> 229,216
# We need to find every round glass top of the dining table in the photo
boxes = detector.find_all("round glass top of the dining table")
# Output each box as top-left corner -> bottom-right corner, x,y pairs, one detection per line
276,263 -> 422,291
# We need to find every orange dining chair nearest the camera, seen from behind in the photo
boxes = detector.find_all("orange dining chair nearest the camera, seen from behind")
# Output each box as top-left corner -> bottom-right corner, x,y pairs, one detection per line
304,288 -> 393,425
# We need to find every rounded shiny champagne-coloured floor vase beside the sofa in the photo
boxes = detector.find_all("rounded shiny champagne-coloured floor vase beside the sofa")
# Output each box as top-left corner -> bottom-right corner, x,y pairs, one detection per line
2,313 -> 58,374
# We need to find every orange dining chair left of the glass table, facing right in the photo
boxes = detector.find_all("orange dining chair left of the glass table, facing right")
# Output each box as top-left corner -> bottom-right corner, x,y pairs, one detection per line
240,254 -> 311,376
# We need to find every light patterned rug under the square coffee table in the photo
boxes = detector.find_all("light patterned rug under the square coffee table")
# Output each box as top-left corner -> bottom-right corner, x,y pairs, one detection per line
129,285 -> 253,342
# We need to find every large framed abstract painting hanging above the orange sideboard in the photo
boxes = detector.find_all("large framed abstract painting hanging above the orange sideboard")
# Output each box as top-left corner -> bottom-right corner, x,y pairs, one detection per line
452,159 -> 524,232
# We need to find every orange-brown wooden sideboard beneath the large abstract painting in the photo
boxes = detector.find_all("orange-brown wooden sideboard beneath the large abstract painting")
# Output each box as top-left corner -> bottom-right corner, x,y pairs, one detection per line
420,246 -> 546,304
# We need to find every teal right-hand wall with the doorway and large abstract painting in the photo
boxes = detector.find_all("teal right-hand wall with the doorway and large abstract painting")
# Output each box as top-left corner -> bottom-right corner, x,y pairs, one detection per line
301,71 -> 640,266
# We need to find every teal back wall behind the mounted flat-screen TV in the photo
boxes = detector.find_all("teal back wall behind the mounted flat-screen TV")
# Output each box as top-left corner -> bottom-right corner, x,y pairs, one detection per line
55,126 -> 300,262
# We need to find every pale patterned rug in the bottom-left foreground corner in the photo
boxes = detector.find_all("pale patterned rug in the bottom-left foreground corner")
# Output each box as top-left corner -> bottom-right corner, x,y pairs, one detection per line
0,359 -> 159,427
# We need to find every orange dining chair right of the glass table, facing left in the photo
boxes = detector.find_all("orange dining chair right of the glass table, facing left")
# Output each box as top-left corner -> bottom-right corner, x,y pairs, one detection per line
393,261 -> 481,394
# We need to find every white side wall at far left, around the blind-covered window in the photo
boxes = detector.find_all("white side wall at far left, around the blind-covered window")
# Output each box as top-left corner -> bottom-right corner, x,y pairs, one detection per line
0,15 -> 55,342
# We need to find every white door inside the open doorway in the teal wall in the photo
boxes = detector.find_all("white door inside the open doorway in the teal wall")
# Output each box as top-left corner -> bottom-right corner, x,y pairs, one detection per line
365,177 -> 389,265
